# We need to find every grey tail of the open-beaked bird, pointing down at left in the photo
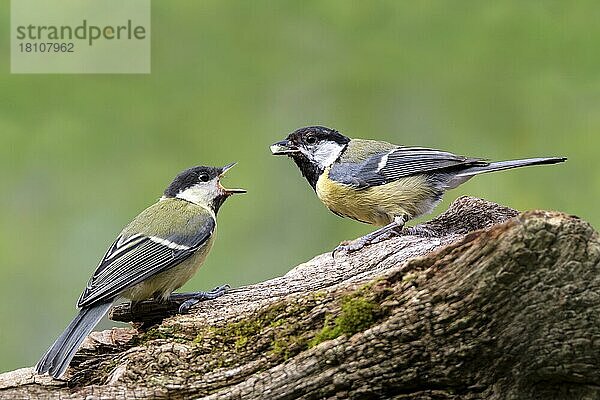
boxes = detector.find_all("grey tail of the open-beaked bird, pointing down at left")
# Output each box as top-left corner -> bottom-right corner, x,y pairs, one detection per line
35,302 -> 112,378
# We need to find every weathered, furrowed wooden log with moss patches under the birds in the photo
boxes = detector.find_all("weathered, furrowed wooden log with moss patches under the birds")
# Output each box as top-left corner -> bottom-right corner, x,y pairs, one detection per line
0,197 -> 600,399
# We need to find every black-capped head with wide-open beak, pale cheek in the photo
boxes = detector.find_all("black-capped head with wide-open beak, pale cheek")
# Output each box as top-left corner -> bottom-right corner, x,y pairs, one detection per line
163,163 -> 246,212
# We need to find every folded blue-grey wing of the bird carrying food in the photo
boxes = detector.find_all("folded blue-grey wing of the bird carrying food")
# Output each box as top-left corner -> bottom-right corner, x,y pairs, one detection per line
329,147 -> 488,189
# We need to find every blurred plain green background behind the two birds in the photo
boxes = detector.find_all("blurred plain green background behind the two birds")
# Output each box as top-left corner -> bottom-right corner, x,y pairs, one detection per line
0,0 -> 600,371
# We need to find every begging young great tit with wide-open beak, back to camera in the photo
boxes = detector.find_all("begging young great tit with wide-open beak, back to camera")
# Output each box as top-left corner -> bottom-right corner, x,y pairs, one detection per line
35,163 -> 246,378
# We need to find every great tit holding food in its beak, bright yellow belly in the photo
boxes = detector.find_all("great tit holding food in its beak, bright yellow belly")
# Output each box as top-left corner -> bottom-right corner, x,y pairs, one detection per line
271,126 -> 566,254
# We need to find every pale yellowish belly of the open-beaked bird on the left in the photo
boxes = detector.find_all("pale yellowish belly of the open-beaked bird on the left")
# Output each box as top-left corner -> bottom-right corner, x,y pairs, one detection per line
121,234 -> 214,301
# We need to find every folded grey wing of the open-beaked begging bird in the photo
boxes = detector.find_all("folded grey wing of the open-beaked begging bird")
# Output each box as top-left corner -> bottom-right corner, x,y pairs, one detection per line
77,217 -> 216,307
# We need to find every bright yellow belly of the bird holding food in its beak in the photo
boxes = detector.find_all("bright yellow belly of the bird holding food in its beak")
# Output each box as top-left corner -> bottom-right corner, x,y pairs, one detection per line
316,168 -> 437,226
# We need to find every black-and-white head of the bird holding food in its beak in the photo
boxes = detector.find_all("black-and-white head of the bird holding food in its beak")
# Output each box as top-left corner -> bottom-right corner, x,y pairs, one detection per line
271,126 -> 350,189
